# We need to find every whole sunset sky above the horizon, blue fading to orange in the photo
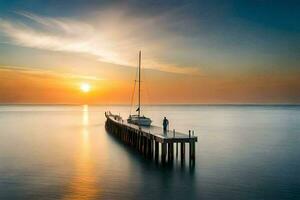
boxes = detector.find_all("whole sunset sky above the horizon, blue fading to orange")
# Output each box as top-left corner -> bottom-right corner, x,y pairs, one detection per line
0,0 -> 300,104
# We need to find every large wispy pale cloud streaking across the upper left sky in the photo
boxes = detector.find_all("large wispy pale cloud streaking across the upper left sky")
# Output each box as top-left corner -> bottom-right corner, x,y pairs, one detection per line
0,11 -> 199,74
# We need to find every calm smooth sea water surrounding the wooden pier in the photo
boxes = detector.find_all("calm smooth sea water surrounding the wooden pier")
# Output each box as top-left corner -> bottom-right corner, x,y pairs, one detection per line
0,106 -> 300,200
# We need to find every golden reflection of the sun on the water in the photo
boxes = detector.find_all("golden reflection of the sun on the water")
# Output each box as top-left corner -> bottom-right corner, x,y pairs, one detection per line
65,105 -> 99,200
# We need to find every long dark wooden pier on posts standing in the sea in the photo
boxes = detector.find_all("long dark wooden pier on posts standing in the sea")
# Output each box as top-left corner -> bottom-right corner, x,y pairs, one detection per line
105,112 -> 197,163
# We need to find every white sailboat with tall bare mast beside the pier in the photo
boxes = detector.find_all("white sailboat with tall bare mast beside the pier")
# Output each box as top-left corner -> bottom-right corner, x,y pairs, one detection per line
127,51 -> 152,126
